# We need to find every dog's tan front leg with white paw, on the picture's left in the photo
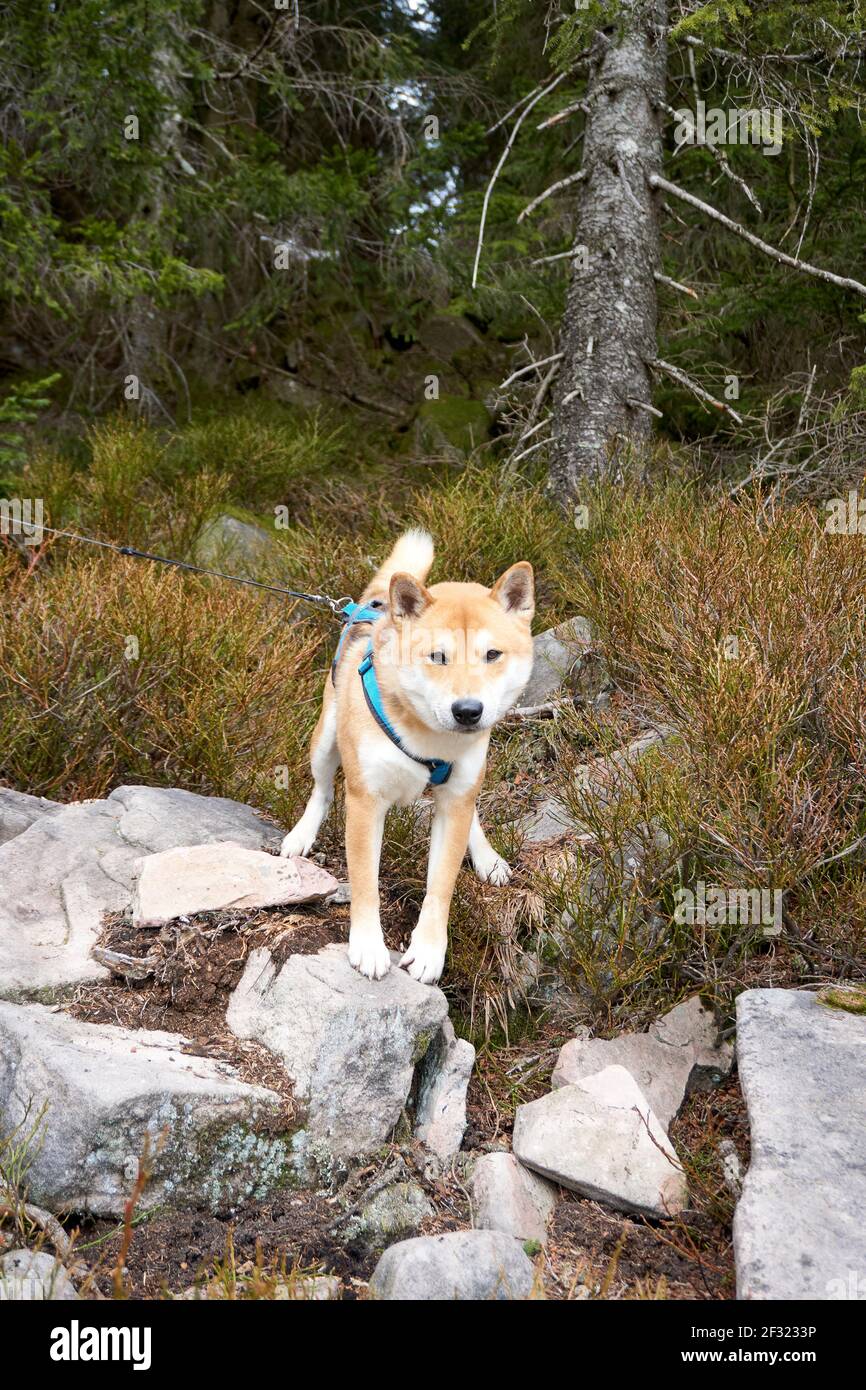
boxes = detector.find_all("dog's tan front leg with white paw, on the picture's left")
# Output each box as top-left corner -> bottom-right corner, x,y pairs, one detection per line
346,787 -> 391,980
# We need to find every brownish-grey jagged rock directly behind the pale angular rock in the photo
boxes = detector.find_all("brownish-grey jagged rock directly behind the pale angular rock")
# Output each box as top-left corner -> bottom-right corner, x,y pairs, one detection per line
550,995 -> 734,1130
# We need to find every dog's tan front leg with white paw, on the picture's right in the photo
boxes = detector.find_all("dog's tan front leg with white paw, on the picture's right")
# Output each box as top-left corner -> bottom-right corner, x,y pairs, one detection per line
400,792 -> 475,984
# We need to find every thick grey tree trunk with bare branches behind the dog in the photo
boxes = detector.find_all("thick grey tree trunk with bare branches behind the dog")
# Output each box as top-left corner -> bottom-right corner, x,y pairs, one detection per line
550,0 -> 667,505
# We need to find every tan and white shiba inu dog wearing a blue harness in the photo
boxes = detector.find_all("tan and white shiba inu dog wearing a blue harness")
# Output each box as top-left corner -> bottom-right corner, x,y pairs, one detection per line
281,531 -> 535,984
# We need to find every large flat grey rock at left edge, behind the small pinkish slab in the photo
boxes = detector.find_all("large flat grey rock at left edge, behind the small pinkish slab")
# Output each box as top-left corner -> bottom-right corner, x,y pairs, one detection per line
0,787 -> 281,1002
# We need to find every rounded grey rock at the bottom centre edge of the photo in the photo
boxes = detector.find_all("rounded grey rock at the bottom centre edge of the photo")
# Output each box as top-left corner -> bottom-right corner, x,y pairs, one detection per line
370,1230 -> 535,1302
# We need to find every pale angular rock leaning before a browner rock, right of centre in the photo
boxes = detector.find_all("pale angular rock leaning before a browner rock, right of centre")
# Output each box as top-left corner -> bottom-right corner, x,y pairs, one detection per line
512,1066 -> 688,1218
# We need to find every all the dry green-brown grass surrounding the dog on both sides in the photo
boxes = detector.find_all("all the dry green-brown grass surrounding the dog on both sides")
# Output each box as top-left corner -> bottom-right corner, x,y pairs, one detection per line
0,409 -> 866,1041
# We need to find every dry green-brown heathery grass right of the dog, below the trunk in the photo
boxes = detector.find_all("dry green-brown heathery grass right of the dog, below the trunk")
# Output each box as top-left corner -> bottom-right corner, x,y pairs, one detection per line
536,488 -> 866,1027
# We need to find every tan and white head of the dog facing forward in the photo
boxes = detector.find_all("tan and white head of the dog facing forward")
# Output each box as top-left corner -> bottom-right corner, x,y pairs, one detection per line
377,560 -> 535,734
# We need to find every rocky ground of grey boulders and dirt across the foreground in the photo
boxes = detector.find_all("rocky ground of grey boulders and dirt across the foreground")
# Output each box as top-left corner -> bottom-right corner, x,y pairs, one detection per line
0,624 -> 866,1300
